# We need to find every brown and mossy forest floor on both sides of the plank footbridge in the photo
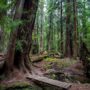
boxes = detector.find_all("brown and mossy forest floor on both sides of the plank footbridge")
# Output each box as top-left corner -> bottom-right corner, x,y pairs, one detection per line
0,55 -> 90,90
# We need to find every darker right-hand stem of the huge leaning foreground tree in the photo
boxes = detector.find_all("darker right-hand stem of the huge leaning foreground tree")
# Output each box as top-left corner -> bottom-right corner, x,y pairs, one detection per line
15,0 -> 38,71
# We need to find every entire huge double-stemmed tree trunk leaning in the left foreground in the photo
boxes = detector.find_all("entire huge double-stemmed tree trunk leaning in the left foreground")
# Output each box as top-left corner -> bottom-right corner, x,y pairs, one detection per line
2,0 -> 38,73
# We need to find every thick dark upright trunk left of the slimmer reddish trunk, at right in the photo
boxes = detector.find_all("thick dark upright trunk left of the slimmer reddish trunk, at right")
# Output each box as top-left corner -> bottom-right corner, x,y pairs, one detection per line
65,0 -> 73,57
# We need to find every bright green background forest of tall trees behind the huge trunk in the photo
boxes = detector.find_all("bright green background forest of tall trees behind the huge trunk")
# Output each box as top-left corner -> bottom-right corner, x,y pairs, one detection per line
0,0 -> 90,57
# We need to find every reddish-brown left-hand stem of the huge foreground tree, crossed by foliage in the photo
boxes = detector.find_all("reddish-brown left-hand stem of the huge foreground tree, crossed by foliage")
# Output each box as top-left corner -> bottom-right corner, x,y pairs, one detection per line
5,0 -> 24,74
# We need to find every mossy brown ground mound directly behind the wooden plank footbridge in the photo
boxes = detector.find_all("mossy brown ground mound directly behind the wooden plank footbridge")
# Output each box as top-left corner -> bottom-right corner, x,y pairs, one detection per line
34,58 -> 87,83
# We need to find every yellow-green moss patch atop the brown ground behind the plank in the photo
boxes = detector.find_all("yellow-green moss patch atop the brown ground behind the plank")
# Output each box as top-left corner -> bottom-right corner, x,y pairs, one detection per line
44,58 -> 76,69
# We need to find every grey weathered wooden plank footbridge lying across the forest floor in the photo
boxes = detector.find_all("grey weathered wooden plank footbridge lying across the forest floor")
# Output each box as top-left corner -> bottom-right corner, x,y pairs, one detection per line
26,75 -> 72,90
